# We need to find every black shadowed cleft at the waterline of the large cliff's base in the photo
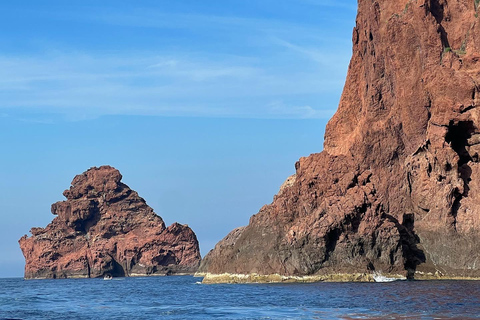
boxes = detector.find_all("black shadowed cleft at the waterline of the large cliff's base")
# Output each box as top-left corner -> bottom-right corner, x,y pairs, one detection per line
385,213 -> 426,279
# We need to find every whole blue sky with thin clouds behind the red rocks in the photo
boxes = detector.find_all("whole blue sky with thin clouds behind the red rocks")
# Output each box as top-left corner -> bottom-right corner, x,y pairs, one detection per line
0,0 -> 356,277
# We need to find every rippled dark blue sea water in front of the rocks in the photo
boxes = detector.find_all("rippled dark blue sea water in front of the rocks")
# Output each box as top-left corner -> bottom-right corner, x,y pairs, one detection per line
0,276 -> 480,320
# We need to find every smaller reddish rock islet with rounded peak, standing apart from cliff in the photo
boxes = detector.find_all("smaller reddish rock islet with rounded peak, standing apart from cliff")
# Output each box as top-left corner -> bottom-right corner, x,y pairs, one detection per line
19,166 -> 200,278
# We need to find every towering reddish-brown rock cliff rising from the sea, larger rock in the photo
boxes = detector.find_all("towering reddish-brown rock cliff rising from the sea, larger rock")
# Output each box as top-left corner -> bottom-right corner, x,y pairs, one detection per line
200,0 -> 480,281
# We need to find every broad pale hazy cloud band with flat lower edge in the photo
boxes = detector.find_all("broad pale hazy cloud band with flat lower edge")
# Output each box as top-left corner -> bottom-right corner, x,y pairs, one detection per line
0,53 -> 343,118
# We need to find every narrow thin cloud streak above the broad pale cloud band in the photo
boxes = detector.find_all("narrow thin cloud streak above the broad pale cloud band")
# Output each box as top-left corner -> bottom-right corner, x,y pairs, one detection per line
51,5 -> 356,46
